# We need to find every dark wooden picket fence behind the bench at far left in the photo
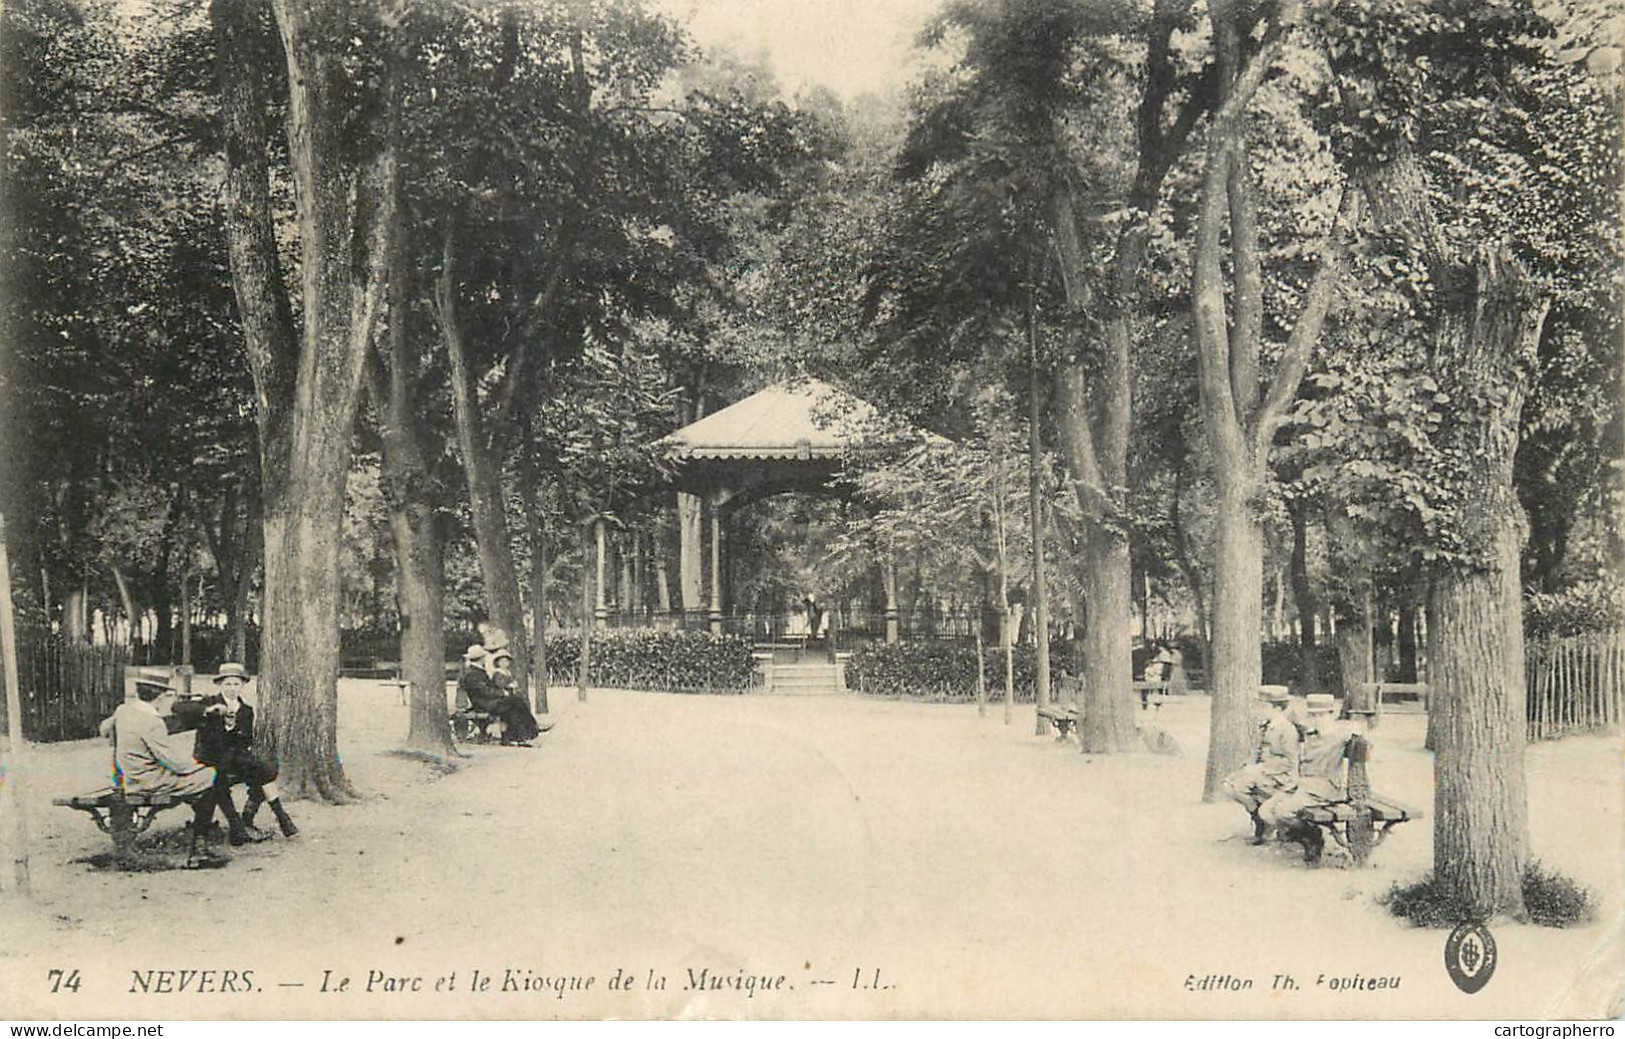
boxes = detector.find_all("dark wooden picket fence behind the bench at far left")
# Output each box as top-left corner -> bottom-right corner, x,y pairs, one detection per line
6,629 -> 130,743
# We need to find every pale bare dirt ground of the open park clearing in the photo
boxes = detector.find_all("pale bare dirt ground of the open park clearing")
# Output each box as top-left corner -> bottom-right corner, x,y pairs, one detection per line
0,681 -> 1625,1019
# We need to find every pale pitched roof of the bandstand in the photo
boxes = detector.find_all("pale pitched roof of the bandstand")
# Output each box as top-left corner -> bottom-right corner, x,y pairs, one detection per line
668,379 -> 878,459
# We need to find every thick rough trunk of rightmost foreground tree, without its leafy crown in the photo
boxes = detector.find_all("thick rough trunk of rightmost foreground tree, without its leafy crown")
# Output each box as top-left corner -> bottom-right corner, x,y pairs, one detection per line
1363,150 -> 1550,919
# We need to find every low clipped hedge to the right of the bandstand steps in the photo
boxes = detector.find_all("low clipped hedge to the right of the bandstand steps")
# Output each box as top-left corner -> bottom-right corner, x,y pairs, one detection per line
847,639 -> 1071,704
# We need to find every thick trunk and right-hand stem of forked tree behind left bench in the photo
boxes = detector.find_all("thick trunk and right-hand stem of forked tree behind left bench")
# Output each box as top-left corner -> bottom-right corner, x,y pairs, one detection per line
247,0 -> 395,800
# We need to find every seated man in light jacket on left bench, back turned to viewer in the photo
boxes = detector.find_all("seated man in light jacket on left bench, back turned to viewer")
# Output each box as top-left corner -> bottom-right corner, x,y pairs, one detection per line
101,672 -> 229,867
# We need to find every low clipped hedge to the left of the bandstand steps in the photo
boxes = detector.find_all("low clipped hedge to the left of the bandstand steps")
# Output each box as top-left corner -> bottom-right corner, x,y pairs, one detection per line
548,629 -> 757,693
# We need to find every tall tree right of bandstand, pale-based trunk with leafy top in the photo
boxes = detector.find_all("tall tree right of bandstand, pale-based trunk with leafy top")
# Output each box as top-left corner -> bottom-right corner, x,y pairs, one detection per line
905,0 -> 1212,753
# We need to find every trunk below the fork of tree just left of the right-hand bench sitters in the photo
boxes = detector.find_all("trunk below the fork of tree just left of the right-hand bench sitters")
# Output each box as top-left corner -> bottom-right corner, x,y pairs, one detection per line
1203,481 -> 1264,802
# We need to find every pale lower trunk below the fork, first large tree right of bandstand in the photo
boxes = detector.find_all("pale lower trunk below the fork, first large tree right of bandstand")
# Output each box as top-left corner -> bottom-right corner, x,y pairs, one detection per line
1077,520 -> 1136,754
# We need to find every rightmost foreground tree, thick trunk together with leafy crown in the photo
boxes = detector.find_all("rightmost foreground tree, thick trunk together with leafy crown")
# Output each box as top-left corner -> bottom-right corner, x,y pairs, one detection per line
1328,0 -> 1619,919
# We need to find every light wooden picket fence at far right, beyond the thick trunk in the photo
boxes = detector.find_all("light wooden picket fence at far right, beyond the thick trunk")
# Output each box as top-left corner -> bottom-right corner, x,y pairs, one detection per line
1524,631 -> 1625,740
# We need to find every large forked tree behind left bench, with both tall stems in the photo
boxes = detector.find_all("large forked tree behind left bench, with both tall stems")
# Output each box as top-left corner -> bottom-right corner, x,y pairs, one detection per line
211,0 -> 395,800
